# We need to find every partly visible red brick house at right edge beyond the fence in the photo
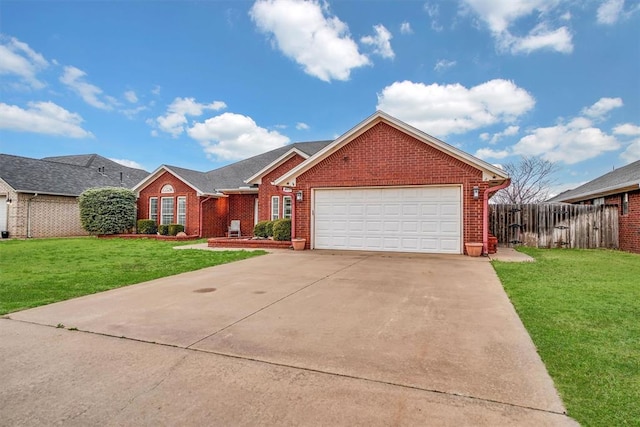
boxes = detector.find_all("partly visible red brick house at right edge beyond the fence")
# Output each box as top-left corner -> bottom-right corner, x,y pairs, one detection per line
548,160 -> 640,253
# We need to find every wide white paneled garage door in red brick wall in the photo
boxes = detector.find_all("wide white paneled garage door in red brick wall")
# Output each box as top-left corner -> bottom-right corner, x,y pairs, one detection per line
313,186 -> 462,254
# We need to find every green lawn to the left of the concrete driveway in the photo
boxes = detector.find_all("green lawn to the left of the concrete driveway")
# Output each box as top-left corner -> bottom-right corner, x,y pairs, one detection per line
0,237 -> 265,315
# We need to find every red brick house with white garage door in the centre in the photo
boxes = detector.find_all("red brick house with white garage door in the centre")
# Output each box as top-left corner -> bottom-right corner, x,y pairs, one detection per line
134,111 -> 509,254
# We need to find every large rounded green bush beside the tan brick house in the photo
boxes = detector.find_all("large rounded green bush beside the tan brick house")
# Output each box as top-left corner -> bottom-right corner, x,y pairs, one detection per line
78,187 -> 136,234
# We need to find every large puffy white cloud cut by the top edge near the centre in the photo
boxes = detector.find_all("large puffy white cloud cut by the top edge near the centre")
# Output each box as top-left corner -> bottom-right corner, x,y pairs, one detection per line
249,0 -> 370,82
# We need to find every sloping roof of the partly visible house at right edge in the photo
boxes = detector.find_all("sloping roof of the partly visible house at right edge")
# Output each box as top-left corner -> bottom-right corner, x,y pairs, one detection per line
548,160 -> 640,203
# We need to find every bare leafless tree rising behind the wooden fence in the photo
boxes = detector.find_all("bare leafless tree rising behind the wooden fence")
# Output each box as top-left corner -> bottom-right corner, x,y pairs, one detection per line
491,156 -> 558,204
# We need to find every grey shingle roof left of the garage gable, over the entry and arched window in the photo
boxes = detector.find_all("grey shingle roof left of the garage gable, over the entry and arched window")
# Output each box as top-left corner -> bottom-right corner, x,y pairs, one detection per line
133,141 -> 331,195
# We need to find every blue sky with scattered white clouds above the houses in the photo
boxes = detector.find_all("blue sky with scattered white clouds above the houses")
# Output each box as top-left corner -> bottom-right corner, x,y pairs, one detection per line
0,0 -> 640,195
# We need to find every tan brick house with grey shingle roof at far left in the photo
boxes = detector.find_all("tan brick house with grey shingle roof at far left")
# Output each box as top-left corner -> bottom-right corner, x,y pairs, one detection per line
0,154 -> 149,238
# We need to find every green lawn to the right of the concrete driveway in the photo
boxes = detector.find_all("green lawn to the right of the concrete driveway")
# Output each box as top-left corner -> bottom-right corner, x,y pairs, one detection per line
493,248 -> 640,426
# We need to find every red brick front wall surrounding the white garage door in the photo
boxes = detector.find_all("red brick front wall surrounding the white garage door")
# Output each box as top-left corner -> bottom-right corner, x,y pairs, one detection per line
290,123 -> 488,251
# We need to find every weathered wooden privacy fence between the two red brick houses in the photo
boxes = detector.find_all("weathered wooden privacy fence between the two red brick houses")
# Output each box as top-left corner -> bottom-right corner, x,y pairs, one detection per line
489,203 -> 618,249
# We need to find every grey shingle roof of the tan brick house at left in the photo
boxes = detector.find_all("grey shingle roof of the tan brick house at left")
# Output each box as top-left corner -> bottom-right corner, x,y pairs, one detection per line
0,154 -> 149,196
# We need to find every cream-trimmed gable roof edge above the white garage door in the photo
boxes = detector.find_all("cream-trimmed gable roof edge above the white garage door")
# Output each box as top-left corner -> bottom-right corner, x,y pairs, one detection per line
274,111 -> 509,186
